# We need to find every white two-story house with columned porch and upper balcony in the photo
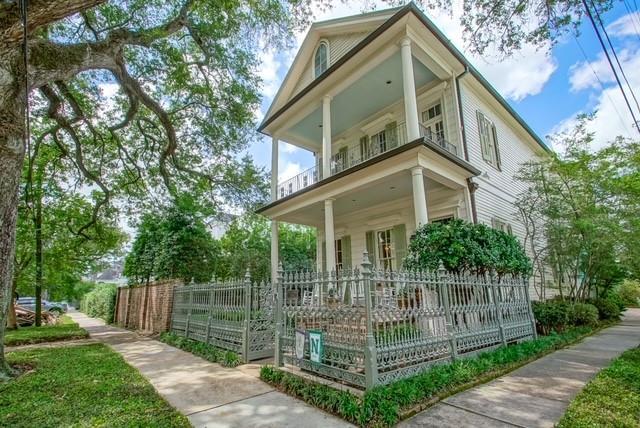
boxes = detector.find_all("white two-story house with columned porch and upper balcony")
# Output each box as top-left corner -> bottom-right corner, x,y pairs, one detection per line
258,3 -> 548,284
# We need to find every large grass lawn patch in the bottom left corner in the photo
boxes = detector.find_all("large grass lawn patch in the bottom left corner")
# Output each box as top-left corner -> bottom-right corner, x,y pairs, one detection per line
0,344 -> 190,427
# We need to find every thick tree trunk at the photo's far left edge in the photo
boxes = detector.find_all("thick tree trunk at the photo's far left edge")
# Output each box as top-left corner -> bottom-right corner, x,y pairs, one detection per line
0,51 -> 26,379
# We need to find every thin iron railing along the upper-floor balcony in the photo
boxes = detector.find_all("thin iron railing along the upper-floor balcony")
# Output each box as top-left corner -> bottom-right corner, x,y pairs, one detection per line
276,122 -> 459,199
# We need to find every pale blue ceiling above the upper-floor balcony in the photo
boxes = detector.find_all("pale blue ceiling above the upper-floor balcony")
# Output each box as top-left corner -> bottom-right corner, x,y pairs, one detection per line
288,51 -> 437,148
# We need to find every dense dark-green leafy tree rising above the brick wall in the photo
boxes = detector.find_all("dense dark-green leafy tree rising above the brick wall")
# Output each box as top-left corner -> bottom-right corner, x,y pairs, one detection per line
124,204 -> 218,283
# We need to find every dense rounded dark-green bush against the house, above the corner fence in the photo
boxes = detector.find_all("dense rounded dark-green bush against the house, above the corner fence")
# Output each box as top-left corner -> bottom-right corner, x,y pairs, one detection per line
404,219 -> 531,276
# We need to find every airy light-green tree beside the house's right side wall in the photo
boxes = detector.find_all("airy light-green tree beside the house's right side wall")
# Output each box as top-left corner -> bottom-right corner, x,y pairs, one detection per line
516,117 -> 640,301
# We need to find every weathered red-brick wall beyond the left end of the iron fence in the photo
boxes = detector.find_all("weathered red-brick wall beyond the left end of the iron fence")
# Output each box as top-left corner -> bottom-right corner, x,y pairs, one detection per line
115,281 -> 180,334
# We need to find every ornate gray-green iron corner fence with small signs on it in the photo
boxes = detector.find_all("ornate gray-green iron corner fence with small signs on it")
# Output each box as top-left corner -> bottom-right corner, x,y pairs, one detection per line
275,252 -> 536,388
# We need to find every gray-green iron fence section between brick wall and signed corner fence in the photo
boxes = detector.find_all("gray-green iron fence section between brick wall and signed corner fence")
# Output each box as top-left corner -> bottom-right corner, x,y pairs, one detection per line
171,272 -> 275,361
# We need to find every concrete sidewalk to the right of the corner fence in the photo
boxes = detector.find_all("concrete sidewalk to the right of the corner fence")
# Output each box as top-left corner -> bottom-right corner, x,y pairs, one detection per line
400,309 -> 640,428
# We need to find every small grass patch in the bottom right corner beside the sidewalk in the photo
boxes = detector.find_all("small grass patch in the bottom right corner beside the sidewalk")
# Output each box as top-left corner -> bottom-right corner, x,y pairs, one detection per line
558,348 -> 640,428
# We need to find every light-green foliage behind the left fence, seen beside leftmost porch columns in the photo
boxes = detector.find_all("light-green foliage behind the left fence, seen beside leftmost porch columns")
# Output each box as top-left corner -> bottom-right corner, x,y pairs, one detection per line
215,214 -> 316,280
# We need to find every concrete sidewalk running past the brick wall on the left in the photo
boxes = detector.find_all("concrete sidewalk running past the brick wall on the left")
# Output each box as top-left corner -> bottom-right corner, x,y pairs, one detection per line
69,312 -> 351,428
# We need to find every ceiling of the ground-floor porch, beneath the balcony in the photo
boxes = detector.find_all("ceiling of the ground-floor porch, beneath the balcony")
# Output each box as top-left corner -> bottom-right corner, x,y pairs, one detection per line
278,171 -> 448,227
